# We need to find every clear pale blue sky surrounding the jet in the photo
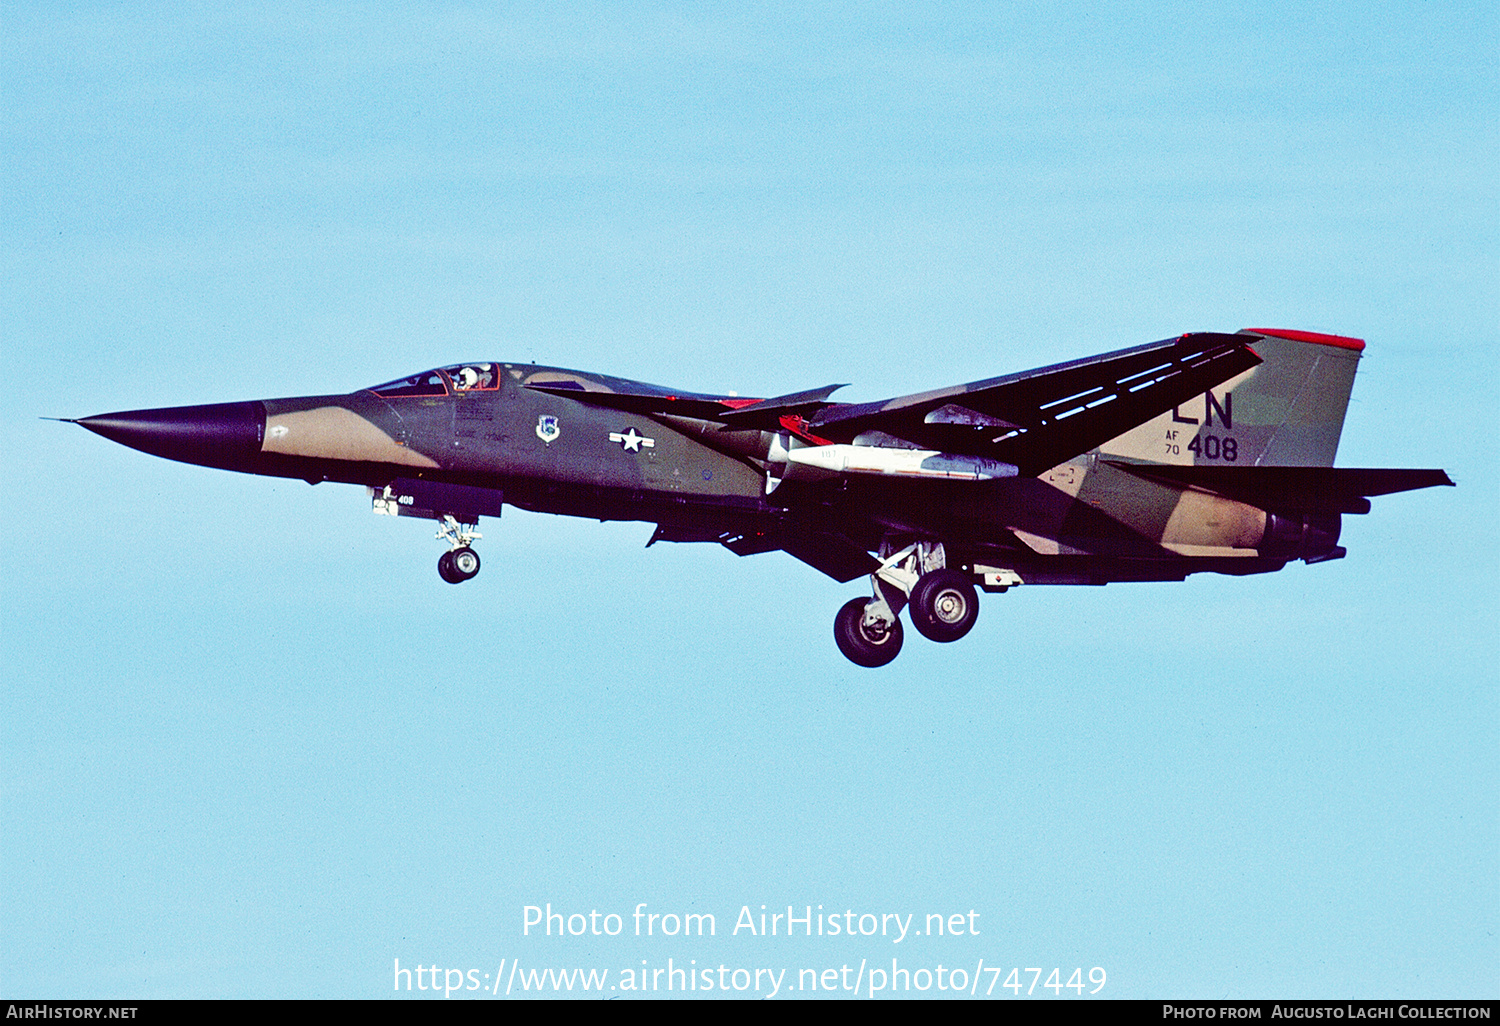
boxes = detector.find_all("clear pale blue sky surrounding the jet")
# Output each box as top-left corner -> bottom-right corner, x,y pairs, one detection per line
0,2 -> 1500,998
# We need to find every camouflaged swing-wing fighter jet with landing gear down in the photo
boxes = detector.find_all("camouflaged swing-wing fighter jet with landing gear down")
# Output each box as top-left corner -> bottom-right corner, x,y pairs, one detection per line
72,329 -> 1452,666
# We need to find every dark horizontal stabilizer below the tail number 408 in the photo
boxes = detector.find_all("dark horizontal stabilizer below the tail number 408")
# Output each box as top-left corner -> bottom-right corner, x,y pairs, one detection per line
1106,459 -> 1454,513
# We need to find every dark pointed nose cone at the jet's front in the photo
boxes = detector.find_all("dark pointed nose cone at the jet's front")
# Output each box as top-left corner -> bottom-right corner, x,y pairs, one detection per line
77,402 -> 266,470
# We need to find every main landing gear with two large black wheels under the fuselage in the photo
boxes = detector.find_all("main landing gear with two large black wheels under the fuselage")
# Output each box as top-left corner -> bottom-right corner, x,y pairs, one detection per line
834,542 -> 980,666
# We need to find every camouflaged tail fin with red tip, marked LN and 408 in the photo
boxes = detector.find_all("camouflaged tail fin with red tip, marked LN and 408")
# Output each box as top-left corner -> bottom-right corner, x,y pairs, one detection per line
1100,329 -> 1365,467
